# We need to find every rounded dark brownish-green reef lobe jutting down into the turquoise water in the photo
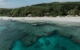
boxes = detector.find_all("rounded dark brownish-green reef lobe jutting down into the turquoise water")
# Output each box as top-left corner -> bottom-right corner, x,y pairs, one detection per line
21,35 -> 40,47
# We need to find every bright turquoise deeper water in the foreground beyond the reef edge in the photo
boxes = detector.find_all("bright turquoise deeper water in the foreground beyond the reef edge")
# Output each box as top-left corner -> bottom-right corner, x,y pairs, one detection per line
12,34 -> 80,50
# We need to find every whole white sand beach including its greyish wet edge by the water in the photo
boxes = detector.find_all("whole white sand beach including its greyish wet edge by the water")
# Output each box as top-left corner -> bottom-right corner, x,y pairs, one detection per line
0,17 -> 80,26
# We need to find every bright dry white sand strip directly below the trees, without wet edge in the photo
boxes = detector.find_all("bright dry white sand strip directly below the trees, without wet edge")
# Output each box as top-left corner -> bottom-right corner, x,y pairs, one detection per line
0,17 -> 80,22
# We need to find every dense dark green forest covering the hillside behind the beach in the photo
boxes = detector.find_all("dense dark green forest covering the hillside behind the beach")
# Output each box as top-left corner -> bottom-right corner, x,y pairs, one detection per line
0,2 -> 80,17
